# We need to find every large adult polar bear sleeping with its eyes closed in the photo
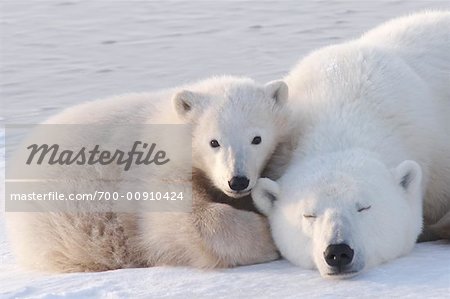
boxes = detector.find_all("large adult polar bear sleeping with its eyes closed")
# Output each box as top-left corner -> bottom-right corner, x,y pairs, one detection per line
253,12 -> 450,277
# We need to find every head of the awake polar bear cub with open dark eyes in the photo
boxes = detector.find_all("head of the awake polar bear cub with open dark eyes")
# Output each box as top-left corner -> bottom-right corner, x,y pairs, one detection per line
173,77 -> 289,197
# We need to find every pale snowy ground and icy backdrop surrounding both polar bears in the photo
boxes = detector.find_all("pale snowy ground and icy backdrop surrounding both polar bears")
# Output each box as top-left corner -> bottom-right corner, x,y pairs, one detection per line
0,0 -> 450,298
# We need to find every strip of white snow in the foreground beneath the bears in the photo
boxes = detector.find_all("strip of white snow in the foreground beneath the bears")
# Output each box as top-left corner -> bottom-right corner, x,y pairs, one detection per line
0,241 -> 450,298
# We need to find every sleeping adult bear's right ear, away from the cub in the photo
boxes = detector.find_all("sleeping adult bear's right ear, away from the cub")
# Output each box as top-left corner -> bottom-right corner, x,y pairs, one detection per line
393,160 -> 422,195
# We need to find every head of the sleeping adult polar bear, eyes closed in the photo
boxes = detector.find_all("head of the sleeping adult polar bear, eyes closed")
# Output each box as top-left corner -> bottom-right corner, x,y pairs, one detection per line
252,154 -> 422,278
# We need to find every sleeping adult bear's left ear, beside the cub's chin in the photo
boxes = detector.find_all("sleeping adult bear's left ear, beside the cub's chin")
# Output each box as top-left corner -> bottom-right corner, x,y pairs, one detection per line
252,178 -> 280,216
